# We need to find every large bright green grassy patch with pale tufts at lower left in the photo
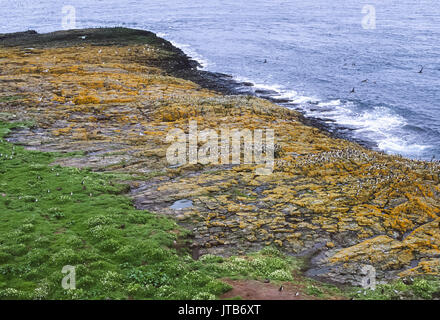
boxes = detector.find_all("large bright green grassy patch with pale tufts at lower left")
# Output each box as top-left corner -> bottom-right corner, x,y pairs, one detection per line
0,122 -> 304,299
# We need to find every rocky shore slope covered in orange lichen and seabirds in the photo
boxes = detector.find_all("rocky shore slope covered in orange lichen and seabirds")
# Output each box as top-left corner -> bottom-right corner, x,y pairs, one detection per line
0,28 -> 440,285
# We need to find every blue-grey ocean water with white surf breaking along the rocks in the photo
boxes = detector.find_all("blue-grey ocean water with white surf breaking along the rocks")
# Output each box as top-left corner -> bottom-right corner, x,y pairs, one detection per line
0,0 -> 440,160
